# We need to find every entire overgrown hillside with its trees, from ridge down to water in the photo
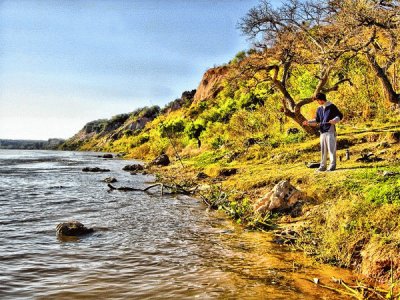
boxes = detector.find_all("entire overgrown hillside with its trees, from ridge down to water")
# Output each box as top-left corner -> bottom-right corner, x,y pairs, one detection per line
60,0 -> 400,279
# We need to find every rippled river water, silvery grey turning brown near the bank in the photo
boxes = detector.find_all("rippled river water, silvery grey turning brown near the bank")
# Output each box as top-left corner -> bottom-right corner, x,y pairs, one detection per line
0,150 -> 356,299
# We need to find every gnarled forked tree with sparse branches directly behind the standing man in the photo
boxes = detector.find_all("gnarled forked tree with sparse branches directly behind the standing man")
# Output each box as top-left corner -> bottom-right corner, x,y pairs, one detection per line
239,0 -> 374,133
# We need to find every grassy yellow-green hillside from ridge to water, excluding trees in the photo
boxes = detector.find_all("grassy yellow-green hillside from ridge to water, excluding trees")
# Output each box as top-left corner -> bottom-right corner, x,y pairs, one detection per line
63,52 -> 400,280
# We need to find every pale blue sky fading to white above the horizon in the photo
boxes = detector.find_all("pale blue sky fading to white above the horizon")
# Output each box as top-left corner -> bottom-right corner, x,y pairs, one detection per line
0,0 -> 272,140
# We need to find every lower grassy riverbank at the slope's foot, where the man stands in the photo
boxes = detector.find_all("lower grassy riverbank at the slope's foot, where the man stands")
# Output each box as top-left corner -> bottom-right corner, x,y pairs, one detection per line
146,126 -> 400,288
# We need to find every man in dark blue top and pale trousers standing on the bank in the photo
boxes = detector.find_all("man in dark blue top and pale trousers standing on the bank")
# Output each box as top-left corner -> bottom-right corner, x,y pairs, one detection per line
303,93 -> 343,171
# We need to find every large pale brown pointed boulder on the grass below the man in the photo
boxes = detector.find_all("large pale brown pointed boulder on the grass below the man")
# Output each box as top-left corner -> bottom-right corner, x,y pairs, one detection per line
254,180 -> 308,213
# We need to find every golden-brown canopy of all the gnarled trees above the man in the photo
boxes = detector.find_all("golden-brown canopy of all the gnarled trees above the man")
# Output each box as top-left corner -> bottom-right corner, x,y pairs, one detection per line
239,0 -> 399,133
